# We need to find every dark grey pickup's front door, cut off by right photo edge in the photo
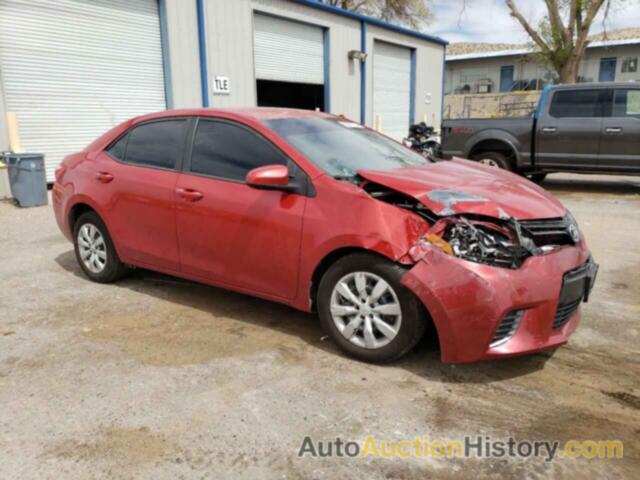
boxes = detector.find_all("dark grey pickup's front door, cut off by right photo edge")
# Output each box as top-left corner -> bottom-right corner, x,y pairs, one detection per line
598,87 -> 640,172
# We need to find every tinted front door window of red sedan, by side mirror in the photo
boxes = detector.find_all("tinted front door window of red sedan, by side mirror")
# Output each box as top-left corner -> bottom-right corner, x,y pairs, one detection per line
191,120 -> 287,181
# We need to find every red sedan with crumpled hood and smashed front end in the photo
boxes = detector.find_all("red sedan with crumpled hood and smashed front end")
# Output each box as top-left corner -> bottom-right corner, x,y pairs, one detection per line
53,108 -> 597,362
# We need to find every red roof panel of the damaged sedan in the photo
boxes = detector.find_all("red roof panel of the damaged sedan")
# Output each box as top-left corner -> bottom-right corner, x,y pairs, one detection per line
131,107 -> 333,125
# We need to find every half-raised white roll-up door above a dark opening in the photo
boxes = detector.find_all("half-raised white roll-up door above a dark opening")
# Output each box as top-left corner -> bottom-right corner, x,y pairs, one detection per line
254,14 -> 324,84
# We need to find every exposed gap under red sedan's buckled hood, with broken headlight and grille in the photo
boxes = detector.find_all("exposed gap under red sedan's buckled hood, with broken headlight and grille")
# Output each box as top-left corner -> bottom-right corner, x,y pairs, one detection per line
361,182 -> 580,269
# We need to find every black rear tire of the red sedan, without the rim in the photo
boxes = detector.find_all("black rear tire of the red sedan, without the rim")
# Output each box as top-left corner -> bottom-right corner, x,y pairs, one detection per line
73,212 -> 129,283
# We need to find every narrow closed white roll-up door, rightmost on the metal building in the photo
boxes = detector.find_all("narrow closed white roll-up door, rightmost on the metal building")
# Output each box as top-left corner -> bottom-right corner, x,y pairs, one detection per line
373,42 -> 411,140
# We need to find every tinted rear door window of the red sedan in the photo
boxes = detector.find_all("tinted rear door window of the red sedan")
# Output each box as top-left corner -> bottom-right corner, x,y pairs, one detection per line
122,119 -> 187,169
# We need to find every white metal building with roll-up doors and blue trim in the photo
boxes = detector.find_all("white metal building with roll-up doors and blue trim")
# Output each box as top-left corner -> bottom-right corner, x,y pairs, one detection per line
0,0 -> 446,181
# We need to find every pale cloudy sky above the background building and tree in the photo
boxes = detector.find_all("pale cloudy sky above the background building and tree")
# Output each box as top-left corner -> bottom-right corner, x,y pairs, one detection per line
424,0 -> 640,43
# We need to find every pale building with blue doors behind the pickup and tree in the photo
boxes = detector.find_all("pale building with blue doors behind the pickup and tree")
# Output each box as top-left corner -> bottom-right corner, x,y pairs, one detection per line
445,28 -> 640,94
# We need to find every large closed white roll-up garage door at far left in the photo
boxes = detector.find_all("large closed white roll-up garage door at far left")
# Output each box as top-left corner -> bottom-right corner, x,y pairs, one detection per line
0,0 -> 166,181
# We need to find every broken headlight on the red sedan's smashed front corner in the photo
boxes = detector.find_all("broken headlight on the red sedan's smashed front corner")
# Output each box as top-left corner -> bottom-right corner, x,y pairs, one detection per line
426,217 -> 535,268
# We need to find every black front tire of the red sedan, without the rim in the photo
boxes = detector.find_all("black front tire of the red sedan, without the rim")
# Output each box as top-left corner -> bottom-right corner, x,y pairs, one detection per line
317,253 -> 427,363
